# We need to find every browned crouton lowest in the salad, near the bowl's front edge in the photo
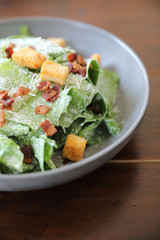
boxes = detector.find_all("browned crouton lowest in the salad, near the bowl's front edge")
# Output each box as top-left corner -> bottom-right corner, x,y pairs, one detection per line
63,134 -> 87,162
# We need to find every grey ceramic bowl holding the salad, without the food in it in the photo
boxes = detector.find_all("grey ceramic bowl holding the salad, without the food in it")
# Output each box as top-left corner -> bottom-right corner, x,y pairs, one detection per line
0,17 -> 149,191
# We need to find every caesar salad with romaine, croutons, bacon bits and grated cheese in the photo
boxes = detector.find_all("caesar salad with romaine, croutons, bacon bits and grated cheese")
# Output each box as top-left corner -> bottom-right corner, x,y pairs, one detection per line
0,26 -> 120,174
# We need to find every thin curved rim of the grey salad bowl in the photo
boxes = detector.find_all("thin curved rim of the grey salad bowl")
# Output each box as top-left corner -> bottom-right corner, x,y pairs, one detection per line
0,16 -> 150,180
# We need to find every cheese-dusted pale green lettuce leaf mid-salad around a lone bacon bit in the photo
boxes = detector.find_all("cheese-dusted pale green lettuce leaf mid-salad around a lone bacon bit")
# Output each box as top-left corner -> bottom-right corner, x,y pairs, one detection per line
6,88 -> 71,130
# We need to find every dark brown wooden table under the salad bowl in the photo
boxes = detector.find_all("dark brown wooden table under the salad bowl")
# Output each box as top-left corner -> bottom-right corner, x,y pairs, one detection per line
0,0 -> 160,240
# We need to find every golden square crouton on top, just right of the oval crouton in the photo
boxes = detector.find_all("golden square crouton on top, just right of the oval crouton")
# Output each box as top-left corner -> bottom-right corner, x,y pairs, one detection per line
40,60 -> 69,86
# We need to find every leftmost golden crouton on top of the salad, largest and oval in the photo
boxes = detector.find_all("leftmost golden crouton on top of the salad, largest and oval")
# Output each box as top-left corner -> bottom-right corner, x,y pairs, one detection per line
12,47 -> 46,69
